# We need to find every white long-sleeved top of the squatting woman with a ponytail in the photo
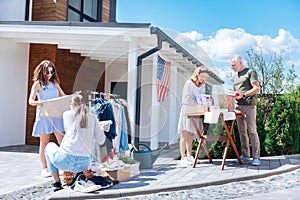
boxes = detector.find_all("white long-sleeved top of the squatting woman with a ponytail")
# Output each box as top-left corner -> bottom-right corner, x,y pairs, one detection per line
60,110 -> 105,157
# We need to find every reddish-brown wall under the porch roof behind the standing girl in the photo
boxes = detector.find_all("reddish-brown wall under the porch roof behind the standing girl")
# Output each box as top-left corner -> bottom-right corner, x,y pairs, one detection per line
26,44 -> 105,145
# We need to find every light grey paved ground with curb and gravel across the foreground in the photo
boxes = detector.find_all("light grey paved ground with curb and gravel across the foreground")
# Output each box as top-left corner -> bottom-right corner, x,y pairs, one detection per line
0,145 -> 300,200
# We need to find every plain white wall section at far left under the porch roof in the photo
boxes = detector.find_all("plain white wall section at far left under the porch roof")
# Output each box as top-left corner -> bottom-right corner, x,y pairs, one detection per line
0,38 -> 29,146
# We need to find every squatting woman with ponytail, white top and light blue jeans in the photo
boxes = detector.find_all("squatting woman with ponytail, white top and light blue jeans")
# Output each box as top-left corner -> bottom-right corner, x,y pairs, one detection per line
45,94 -> 106,191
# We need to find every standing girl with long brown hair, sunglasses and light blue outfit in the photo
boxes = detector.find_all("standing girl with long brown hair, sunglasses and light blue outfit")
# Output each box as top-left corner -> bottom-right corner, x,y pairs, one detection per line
28,60 -> 65,177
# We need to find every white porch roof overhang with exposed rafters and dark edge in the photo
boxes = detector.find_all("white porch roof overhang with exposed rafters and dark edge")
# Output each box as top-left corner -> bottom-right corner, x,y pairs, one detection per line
0,21 -> 224,85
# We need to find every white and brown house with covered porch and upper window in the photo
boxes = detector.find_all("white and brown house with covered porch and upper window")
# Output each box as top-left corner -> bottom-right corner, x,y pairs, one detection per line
0,0 -> 223,149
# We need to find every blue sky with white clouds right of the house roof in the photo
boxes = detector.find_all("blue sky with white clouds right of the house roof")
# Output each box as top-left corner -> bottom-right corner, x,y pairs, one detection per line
117,0 -> 300,90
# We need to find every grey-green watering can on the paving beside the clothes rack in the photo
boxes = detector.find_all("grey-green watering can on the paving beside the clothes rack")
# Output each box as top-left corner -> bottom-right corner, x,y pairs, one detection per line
131,144 -> 163,169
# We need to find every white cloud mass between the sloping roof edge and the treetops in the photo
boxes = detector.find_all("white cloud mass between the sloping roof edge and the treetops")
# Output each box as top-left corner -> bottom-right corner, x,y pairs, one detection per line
175,28 -> 300,90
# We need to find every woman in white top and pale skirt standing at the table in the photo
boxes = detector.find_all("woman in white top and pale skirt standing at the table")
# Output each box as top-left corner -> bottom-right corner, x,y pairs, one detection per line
178,66 -> 209,165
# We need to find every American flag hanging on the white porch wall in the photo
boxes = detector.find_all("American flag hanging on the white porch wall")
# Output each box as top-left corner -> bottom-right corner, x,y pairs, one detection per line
156,56 -> 170,102
